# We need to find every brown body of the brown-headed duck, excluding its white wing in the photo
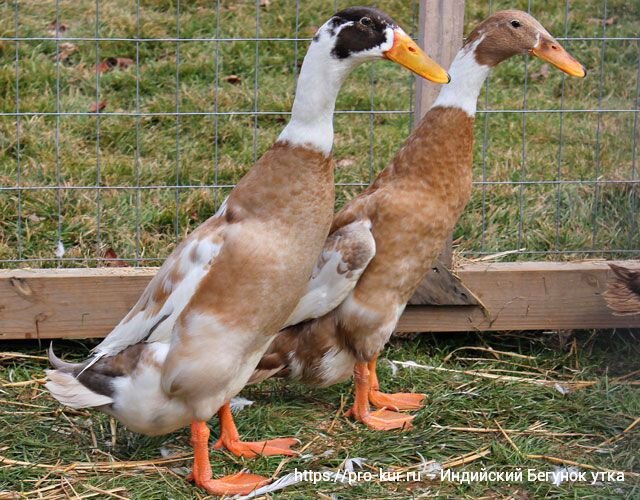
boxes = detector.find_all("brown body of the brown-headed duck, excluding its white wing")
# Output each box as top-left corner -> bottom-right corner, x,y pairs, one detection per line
258,107 -> 473,386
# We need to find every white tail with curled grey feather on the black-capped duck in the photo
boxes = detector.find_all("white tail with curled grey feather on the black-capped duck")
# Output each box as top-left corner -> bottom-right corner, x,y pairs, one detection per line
44,343 -> 113,408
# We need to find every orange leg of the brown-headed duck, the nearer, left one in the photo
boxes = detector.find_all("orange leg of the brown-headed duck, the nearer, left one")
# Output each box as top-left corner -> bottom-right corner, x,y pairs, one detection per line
347,363 -> 413,431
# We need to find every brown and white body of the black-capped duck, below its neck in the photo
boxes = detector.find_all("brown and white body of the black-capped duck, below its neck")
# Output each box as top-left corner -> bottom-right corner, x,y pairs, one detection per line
54,143 -> 334,434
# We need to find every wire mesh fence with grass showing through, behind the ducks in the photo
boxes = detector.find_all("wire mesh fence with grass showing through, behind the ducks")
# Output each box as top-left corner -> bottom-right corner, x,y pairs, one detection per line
0,0 -> 640,267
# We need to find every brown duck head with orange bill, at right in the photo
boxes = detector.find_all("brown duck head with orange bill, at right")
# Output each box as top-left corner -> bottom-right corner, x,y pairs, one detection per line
465,9 -> 587,78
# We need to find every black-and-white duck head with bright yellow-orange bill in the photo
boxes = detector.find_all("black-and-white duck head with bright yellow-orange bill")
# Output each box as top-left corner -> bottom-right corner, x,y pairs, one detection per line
312,7 -> 450,83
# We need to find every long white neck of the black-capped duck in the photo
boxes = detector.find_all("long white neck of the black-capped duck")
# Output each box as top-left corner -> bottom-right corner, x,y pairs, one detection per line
278,42 -> 352,156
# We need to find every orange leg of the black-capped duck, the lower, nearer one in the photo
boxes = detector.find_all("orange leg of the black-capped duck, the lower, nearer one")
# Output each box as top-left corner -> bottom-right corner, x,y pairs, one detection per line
188,420 -> 269,496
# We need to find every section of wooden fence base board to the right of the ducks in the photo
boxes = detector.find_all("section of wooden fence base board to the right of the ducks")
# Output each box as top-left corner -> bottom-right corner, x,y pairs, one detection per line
398,261 -> 640,332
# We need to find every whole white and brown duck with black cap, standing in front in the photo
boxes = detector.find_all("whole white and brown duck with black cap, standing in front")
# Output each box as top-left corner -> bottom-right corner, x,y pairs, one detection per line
46,4 -> 448,494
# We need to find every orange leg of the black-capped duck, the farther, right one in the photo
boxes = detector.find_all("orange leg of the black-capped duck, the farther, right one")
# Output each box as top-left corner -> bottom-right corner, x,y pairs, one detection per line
213,403 -> 300,458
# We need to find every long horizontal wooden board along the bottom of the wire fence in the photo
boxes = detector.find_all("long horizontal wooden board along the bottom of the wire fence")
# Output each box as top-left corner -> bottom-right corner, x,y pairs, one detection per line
0,260 -> 640,339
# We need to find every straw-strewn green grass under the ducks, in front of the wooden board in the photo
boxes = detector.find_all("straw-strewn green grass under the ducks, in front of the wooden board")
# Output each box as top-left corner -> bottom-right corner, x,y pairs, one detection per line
0,331 -> 640,498
